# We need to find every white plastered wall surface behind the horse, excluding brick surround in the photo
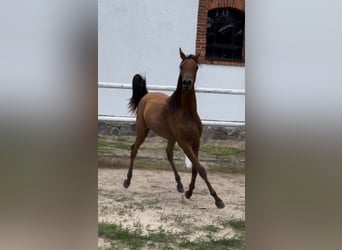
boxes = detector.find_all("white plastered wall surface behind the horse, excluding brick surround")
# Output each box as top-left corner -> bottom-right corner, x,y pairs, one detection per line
98,0 -> 245,121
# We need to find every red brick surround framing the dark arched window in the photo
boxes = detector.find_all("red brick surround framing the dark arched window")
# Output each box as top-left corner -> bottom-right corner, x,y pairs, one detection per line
196,0 -> 245,66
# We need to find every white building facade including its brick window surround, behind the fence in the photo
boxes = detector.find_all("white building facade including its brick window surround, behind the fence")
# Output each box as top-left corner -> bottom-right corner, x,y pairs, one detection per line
98,0 -> 245,121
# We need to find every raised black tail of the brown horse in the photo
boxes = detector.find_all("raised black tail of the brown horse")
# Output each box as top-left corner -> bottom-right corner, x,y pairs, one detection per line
128,74 -> 147,113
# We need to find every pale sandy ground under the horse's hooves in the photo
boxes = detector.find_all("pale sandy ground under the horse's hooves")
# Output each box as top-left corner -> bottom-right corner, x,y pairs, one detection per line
98,169 -> 245,249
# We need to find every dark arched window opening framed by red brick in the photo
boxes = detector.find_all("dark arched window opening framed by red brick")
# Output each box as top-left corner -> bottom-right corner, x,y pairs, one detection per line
206,8 -> 245,62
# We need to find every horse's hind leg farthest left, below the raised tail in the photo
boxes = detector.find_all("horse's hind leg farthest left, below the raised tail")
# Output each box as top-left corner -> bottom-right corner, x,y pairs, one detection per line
123,125 -> 149,188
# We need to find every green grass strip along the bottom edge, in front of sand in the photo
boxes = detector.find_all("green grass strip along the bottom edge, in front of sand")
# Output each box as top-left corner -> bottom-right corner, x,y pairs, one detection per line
98,220 -> 245,250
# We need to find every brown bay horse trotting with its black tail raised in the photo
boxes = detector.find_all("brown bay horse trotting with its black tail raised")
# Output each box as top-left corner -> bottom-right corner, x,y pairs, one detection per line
123,48 -> 225,208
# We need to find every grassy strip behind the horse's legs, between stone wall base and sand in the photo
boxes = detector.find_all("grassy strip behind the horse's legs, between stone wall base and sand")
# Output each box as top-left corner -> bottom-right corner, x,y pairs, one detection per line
98,137 -> 245,174
